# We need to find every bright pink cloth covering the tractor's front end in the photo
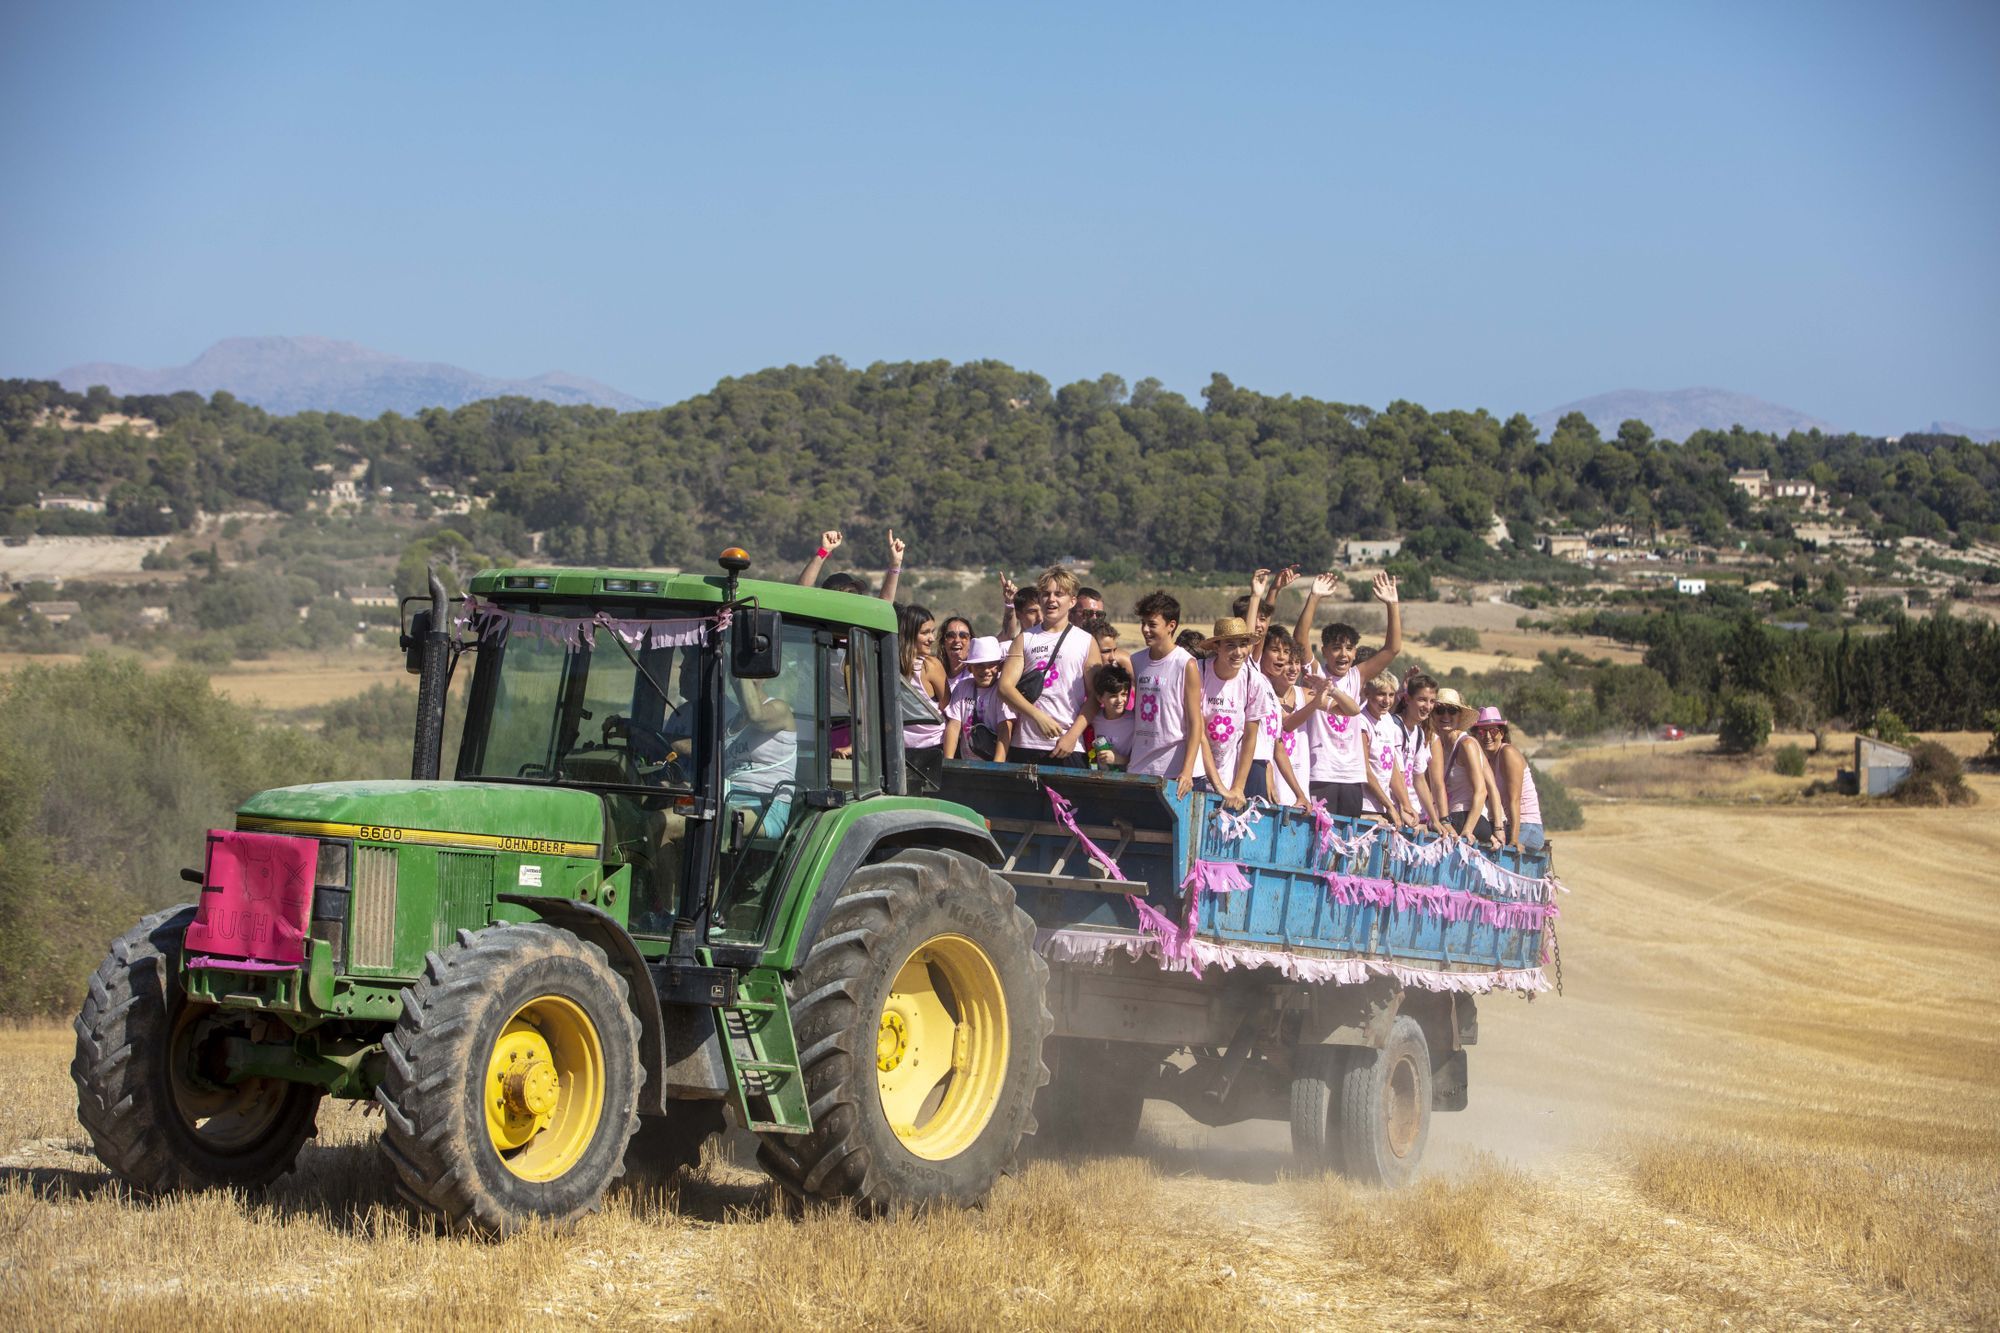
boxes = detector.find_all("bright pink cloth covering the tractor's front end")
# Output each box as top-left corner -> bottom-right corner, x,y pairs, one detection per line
182,829 -> 320,963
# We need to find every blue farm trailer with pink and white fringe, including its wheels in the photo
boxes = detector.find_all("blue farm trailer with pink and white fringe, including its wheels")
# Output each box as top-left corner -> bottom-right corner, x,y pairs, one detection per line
942,763 -> 1558,1185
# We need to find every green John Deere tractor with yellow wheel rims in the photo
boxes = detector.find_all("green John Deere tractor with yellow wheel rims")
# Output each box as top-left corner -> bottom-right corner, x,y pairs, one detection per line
72,550 -> 1050,1235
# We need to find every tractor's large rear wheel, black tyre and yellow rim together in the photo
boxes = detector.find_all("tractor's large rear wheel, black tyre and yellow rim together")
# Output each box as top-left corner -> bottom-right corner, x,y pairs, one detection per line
758,849 -> 1052,1211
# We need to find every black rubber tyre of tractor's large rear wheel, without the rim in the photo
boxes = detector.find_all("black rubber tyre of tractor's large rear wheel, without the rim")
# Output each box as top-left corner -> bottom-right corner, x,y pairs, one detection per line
758,849 -> 1054,1213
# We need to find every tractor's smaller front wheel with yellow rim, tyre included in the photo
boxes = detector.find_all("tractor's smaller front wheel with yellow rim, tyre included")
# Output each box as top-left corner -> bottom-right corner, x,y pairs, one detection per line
376,925 -> 646,1235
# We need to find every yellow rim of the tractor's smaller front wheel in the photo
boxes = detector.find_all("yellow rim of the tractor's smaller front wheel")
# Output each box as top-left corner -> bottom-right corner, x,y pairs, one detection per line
482,995 -> 604,1181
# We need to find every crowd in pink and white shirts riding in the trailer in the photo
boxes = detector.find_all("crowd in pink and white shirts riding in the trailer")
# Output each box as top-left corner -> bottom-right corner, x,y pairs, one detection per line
798,530 -> 1544,851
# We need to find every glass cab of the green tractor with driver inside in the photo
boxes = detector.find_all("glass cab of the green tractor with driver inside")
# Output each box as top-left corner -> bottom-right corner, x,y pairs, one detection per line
446,552 -> 902,953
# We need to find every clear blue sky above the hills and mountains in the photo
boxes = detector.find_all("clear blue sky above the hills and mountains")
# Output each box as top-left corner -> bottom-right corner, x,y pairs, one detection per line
0,0 -> 2000,430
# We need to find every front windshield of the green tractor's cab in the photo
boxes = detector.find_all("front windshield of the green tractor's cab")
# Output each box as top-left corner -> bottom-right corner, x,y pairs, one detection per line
458,602 -> 710,791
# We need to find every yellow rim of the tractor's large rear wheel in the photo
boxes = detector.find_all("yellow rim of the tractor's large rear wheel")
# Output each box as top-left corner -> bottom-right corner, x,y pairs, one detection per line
876,935 -> 1008,1161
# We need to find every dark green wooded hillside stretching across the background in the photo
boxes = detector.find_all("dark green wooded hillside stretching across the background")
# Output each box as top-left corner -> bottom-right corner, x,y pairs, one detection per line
0,358 -> 2000,572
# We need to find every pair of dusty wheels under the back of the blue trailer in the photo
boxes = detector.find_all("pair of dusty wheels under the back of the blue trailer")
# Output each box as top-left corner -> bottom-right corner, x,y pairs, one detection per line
1292,1015 -> 1432,1189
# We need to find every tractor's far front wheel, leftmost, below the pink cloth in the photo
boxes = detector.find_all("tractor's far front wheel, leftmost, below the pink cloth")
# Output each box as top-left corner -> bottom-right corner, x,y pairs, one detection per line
70,903 -> 322,1195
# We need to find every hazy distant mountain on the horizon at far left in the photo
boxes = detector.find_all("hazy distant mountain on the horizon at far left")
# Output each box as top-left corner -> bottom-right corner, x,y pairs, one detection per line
56,336 -> 658,416
